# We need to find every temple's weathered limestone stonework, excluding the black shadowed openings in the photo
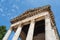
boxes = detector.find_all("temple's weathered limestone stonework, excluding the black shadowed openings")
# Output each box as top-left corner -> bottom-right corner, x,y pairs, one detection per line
3,6 -> 59,40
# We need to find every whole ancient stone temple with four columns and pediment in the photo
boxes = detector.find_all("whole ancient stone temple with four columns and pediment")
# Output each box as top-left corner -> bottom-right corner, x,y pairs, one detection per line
3,5 -> 59,40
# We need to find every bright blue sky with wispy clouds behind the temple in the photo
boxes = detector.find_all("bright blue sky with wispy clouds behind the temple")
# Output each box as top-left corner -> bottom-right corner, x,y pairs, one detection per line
0,0 -> 60,40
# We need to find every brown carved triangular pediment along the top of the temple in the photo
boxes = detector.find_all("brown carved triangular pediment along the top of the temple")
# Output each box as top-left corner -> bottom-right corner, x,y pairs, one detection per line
11,5 -> 54,24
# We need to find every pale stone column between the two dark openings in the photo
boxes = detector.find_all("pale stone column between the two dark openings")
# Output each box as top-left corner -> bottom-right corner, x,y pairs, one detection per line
26,20 -> 35,40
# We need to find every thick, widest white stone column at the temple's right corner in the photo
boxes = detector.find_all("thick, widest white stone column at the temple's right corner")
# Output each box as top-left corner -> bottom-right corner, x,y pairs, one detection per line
45,15 -> 56,40
